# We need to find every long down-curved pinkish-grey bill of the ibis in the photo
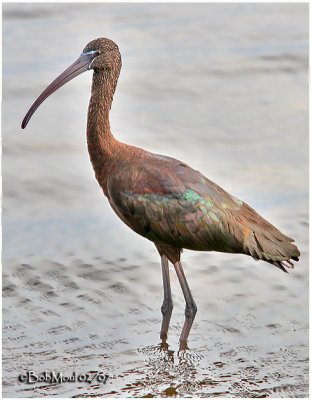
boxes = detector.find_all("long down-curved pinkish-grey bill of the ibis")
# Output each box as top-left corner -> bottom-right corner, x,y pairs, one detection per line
22,53 -> 92,129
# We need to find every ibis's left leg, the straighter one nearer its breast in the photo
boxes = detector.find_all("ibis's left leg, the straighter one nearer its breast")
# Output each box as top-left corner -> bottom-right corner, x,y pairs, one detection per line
160,254 -> 173,341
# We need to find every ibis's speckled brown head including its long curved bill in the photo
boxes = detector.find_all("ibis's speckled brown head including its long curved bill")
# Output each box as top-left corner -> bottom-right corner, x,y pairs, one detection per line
22,38 -> 121,129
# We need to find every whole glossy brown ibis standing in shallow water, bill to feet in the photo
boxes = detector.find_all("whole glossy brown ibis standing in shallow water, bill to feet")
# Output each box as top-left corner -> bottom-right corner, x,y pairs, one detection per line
22,39 -> 300,343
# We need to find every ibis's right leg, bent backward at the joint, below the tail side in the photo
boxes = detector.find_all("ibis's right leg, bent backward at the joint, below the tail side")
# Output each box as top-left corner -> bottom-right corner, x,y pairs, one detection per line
174,261 -> 197,347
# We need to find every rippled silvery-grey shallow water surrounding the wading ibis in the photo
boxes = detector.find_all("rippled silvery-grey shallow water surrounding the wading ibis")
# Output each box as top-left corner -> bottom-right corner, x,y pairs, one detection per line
2,4 -> 309,397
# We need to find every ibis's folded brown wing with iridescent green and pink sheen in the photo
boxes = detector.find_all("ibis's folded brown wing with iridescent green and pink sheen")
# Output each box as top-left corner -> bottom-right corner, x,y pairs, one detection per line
108,155 -> 295,261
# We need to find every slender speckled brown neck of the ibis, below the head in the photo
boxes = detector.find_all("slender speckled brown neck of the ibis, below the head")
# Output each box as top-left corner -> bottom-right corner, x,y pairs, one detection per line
87,69 -> 120,186
